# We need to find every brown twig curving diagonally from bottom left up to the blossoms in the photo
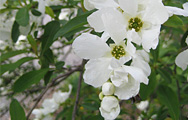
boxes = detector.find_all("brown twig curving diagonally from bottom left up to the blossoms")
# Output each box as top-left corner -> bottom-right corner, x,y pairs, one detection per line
27,67 -> 79,120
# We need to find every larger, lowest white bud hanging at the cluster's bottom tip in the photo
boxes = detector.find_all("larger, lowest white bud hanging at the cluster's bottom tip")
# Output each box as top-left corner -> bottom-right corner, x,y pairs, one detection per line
99,96 -> 120,120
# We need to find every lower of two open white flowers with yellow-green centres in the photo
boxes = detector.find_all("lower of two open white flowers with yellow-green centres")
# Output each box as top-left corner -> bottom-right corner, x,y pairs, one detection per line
72,33 -> 136,87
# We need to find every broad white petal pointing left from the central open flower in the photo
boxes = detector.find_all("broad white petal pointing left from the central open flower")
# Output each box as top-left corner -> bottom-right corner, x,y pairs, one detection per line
72,33 -> 110,59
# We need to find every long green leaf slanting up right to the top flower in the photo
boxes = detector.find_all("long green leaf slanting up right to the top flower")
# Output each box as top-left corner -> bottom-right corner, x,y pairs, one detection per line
54,11 -> 93,39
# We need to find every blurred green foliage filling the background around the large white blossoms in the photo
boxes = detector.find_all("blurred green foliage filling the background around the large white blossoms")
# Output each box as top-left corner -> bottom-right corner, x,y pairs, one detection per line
0,0 -> 188,120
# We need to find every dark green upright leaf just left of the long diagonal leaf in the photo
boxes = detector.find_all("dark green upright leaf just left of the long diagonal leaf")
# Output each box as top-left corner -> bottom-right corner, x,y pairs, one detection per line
41,21 -> 60,55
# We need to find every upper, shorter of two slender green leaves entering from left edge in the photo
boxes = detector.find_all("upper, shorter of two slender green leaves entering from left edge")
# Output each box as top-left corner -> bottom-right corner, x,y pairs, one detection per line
0,50 -> 28,62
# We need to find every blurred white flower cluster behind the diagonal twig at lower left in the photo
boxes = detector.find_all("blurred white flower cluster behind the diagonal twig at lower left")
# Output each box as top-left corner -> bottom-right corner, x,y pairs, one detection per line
32,85 -> 72,120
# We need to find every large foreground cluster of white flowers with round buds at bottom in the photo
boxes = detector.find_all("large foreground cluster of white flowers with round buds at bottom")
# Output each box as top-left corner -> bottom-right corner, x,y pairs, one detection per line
72,0 -> 188,119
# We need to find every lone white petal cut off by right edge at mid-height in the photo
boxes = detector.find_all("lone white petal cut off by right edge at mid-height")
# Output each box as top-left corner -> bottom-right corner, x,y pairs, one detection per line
175,49 -> 188,70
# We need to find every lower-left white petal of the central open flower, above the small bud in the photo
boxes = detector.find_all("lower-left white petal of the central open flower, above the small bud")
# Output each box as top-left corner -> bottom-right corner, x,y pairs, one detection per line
83,58 -> 111,87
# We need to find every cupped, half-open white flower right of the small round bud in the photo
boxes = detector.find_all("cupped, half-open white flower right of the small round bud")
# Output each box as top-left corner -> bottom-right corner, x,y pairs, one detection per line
111,65 -> 149,100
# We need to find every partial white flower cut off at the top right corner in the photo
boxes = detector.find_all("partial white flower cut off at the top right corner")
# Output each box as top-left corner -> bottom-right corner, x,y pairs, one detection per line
166,2 -> 188,17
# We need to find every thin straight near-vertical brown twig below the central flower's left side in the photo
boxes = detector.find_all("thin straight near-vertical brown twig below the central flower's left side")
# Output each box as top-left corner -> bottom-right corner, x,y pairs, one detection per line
72,60 -> 85,120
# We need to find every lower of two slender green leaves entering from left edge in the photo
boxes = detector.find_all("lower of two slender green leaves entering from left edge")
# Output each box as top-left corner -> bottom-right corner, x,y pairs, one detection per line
0,57 -> 36,75
